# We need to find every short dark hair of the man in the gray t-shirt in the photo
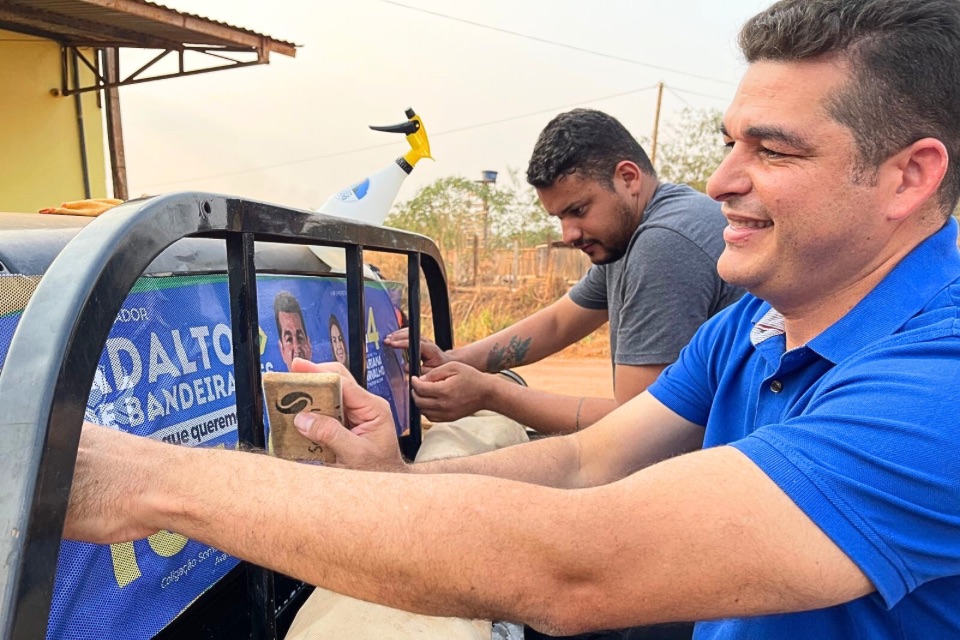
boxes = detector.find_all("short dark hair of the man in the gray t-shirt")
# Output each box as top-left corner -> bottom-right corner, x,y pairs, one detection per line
527,109 -> 657,189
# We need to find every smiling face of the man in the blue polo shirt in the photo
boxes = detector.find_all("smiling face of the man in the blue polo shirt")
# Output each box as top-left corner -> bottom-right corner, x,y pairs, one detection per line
707,61 -> 892,312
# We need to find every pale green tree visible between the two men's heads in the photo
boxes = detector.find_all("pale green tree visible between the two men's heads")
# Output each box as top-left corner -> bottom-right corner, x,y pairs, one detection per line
656,109 -> 726,192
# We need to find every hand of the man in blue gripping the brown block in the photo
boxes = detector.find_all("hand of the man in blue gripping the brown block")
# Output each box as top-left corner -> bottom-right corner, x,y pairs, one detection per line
291,358 -> 406,471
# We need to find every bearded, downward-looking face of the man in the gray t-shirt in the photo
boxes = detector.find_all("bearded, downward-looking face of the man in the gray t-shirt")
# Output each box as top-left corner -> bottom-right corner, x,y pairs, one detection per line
537,163 -> 643,264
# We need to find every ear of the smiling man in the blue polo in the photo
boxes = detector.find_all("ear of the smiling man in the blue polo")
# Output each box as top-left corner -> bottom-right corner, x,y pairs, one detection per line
885,138 -> 950,220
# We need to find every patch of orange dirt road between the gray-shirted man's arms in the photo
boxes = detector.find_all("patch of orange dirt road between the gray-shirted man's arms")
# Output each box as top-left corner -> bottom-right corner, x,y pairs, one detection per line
515,356 -> 613,398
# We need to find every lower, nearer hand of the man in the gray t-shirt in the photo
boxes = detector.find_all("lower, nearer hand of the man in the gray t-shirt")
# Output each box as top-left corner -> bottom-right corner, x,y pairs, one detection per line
410,362 -> 495,422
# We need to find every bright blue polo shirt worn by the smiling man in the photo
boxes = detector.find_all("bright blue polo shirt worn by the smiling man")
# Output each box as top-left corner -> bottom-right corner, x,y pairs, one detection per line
650,218 -> 960,640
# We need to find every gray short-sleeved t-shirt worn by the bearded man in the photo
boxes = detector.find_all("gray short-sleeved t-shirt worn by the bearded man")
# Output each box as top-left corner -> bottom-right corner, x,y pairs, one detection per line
570,183 -> 743,365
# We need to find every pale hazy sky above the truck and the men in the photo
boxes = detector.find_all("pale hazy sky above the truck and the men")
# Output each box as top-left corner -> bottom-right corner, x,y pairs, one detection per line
114,0 -> 769,209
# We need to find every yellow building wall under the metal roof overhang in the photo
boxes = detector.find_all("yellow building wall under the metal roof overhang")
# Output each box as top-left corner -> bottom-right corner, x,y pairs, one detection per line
0,30 -> 108,212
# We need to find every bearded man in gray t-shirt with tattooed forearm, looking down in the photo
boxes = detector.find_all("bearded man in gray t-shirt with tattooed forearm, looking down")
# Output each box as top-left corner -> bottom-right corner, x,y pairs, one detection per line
386,109 -> 742,433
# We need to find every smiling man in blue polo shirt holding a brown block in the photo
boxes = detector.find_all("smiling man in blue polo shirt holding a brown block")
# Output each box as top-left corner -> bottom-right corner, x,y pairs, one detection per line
66,0 -> 960,640
